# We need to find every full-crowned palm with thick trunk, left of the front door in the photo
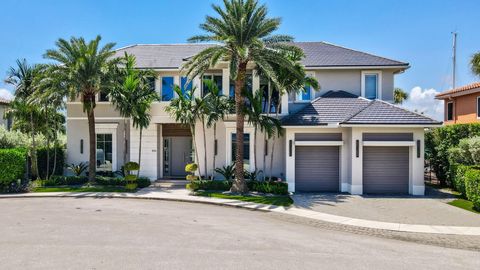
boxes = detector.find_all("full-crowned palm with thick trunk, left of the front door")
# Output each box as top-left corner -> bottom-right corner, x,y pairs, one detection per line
44,36 -> 118,183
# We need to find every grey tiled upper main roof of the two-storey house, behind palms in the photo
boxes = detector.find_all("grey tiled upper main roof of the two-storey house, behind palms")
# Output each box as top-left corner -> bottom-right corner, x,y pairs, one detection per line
116,42 -> 409,69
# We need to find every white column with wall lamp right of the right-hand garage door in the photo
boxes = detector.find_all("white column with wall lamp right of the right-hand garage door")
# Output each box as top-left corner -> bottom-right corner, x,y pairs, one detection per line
409,129 -> 425,195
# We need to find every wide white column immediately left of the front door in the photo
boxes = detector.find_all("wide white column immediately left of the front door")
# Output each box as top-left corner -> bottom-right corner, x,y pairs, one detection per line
130,123 -> 158,180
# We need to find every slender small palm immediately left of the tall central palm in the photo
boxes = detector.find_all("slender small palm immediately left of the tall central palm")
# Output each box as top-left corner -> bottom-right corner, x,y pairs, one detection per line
204,80 -> 233,180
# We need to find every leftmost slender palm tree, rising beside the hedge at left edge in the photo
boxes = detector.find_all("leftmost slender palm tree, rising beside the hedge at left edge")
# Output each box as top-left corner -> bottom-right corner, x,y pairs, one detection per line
5,59 -> 41,177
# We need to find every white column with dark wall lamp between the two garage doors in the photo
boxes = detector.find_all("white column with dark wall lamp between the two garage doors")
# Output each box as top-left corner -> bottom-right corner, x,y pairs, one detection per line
350,128 -> 363,194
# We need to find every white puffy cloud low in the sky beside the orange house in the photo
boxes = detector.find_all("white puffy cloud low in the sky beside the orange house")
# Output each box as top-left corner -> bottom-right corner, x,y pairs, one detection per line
402,86 -> 443,121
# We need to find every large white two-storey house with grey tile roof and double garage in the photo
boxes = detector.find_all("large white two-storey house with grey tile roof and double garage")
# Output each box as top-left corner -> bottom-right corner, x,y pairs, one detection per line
67,42 -> 441,195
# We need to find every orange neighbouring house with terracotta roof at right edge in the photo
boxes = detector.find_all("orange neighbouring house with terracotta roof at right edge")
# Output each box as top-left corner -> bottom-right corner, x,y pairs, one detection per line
435,82 -> 480,125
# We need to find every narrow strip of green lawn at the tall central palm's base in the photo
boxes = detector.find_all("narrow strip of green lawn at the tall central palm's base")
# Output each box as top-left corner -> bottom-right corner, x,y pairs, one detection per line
195,191 -> 293,206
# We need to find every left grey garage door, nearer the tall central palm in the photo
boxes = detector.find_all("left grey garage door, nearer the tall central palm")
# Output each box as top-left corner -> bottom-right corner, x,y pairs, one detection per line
295,146 -> 340,192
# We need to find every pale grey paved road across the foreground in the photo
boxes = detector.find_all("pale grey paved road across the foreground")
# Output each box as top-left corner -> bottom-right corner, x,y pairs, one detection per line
0,198 -> 480,270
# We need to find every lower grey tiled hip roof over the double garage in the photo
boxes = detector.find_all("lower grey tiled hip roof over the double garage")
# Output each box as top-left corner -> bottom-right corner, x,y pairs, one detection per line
282,91 -> 441,126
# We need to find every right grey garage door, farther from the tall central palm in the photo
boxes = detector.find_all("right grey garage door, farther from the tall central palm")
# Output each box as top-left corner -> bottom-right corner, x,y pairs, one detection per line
363,146 -> 409,194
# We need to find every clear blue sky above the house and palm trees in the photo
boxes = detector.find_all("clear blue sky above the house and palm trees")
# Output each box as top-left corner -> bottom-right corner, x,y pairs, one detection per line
0,0 -> 480,118
